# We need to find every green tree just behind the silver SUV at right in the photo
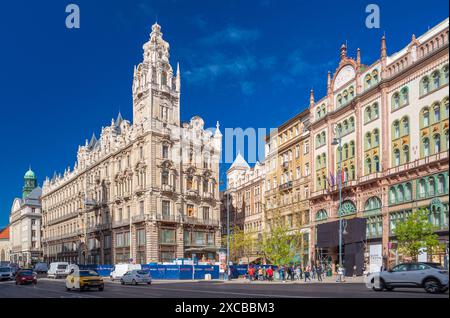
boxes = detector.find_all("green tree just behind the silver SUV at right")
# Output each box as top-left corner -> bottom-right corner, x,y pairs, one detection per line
393,209 -> 440,261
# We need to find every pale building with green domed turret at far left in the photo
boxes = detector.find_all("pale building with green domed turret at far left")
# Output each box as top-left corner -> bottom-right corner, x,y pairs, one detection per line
9,169 -> 42,267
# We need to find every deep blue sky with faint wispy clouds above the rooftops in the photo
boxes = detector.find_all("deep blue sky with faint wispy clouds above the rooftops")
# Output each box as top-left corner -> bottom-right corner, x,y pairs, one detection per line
0,0 -> 449,228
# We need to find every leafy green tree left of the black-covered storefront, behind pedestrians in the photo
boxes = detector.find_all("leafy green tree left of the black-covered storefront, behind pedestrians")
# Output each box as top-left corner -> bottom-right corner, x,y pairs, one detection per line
262,217 -> 302,266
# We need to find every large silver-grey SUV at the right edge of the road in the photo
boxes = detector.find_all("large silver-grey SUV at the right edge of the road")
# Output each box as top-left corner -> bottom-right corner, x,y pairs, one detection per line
369,263 -> 449,294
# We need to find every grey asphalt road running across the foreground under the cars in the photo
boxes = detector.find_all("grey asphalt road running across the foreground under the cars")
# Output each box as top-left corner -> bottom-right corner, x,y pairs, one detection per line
0,279 -> 449,299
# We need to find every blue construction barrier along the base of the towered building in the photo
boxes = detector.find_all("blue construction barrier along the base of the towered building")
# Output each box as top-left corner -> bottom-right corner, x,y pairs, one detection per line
79,264 -> 219,280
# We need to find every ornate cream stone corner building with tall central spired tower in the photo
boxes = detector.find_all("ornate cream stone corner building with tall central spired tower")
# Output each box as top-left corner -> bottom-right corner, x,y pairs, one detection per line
42,24 -> 222,264
